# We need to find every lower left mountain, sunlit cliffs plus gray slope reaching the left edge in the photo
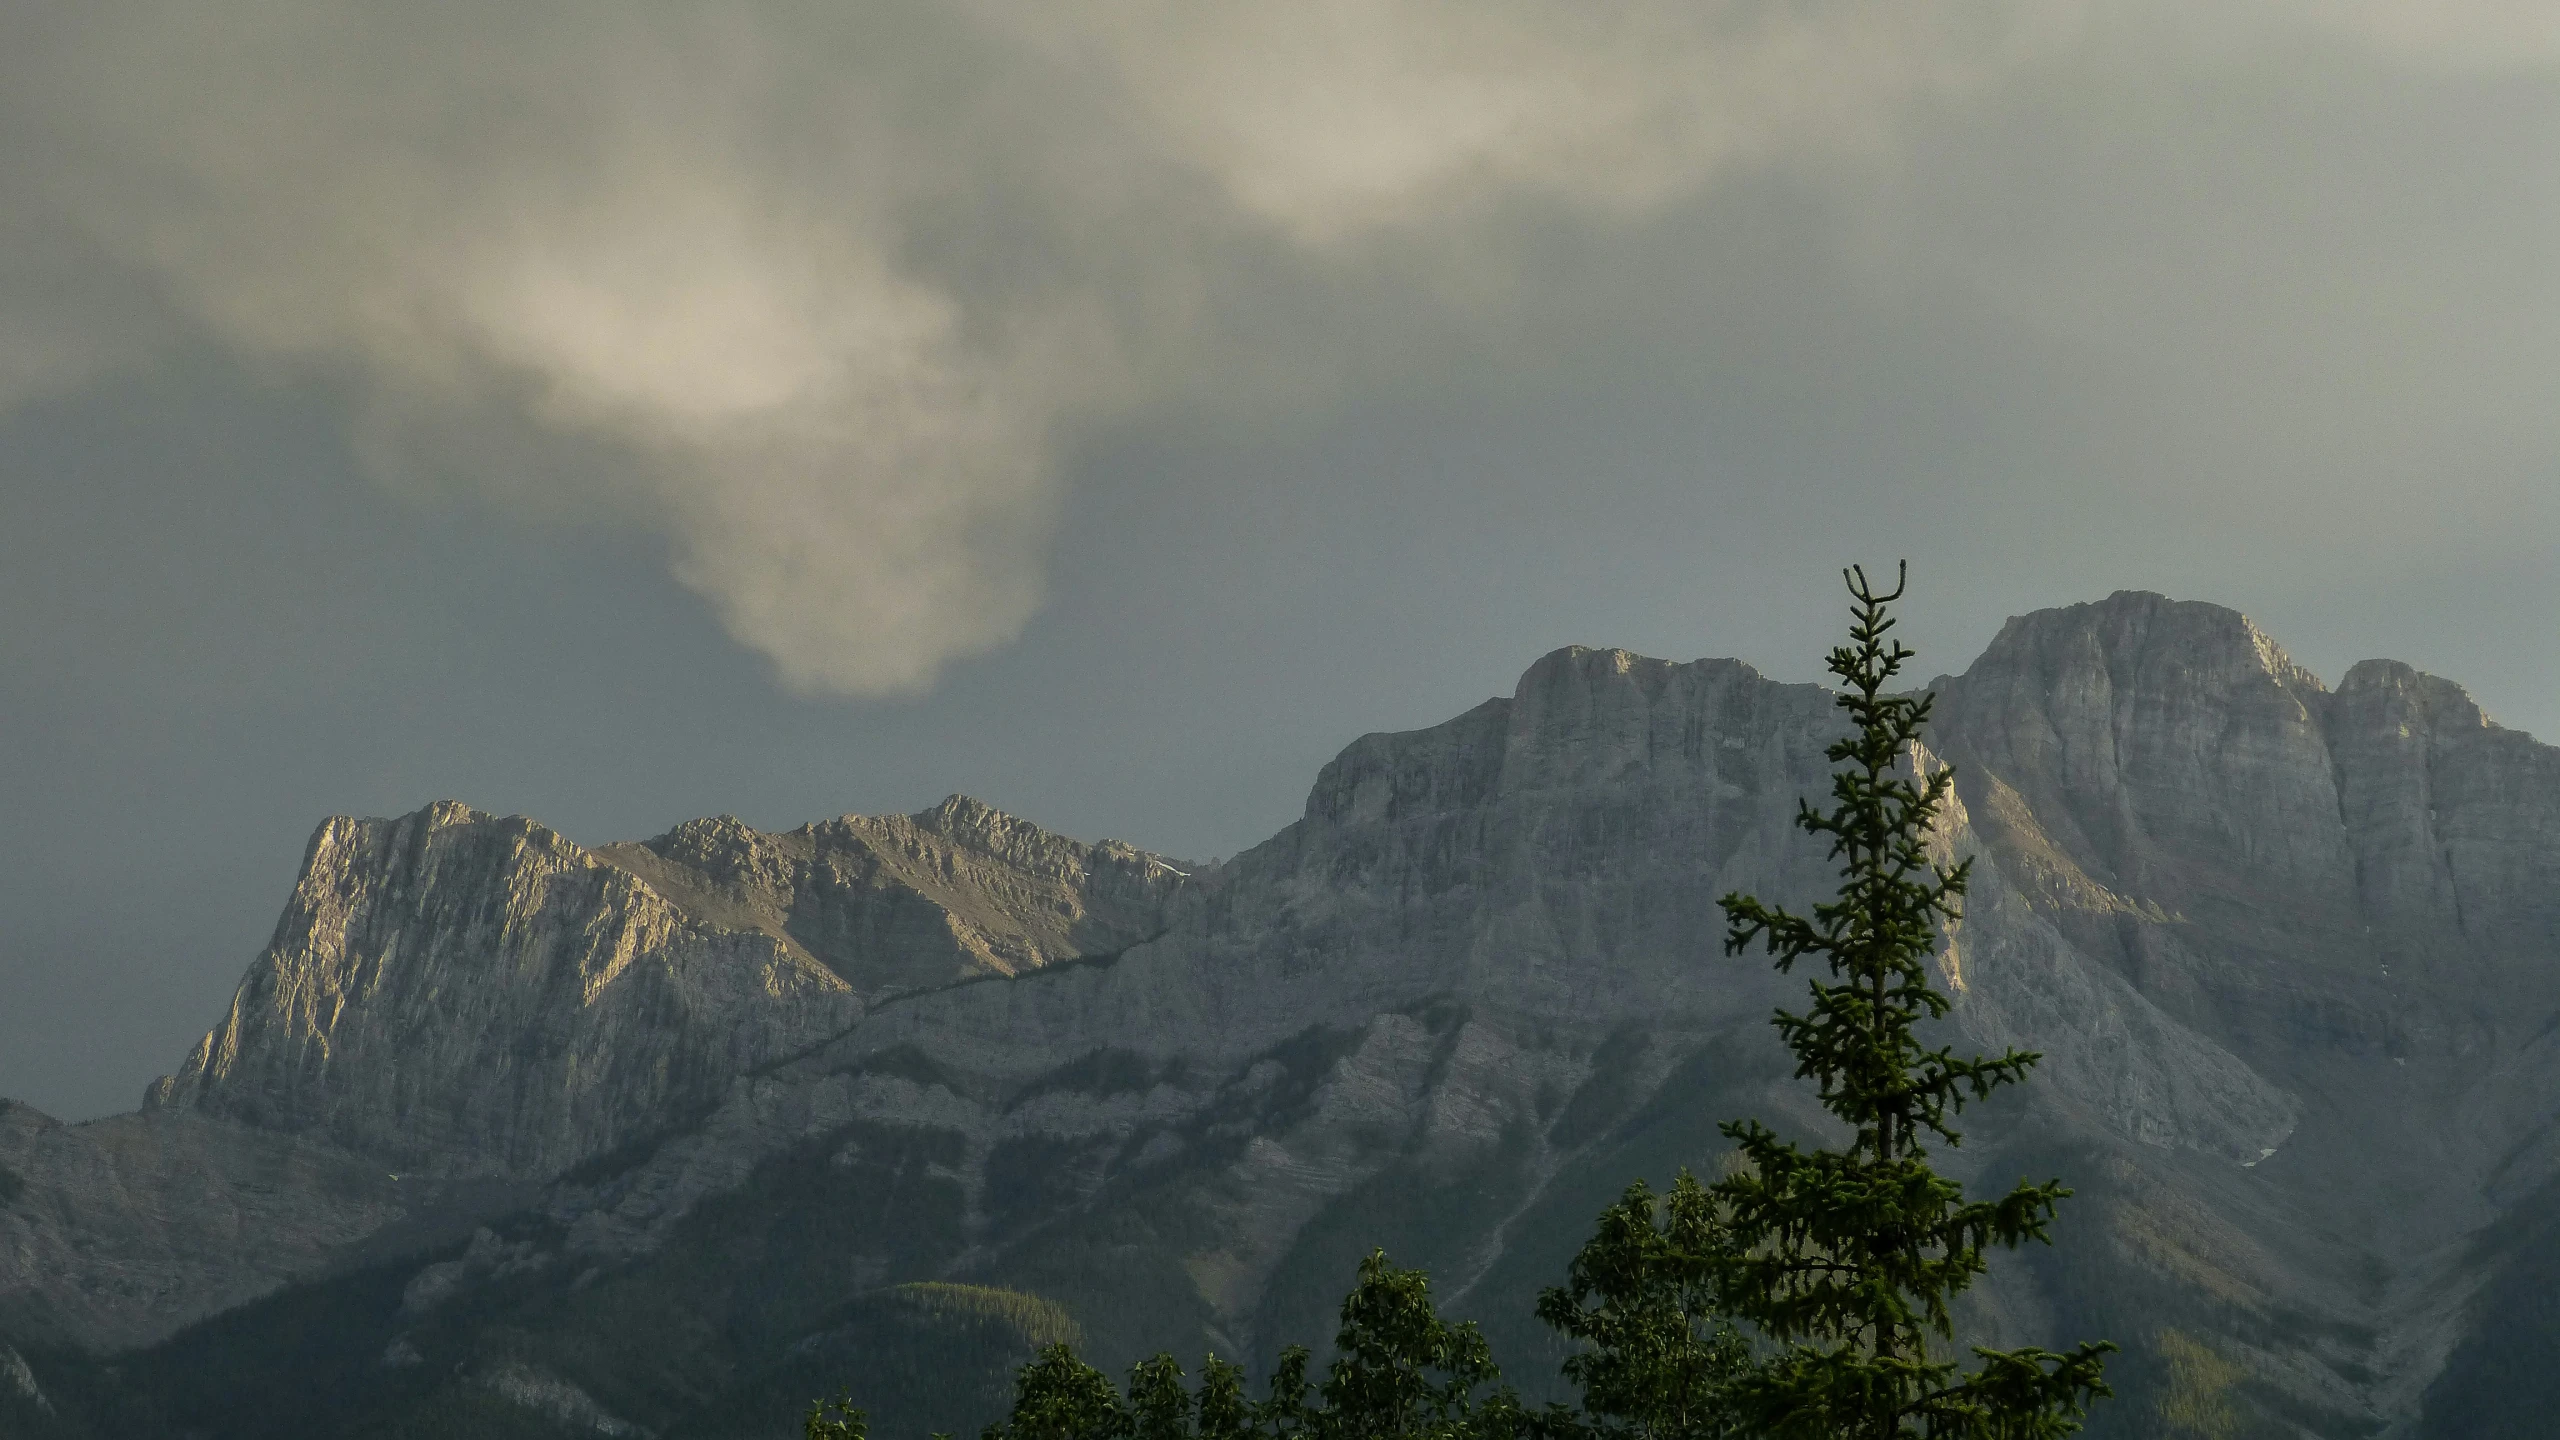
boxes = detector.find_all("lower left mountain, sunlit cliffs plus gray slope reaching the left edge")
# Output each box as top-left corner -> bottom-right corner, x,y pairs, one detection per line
0,797 -> 1185,1348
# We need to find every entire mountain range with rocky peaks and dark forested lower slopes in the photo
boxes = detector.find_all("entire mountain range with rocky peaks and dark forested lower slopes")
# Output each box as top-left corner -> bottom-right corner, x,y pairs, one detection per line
0,594 -> 2560,1437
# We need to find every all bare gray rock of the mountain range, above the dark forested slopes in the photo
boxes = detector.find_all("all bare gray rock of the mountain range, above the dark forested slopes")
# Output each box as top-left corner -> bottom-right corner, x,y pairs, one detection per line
0,594 -> 2560,1432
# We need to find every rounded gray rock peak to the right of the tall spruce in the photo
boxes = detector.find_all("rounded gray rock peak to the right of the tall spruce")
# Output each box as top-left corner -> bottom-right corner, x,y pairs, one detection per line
1935,594 -> 2560,1173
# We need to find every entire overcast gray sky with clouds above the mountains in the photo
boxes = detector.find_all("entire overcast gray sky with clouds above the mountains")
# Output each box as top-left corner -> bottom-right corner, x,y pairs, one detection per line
0,0 -> 2560,1117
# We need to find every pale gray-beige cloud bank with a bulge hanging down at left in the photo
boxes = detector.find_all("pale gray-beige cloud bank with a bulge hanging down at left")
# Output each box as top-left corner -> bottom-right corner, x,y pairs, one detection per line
0,0 -> 2560,692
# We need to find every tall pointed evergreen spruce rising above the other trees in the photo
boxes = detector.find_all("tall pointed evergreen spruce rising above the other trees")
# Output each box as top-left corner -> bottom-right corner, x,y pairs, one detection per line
1713,569 -> 2115,1440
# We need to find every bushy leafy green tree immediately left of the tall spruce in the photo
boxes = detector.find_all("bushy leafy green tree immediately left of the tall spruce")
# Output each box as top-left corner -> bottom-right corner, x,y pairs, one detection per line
1539,1171 -> 1751,1440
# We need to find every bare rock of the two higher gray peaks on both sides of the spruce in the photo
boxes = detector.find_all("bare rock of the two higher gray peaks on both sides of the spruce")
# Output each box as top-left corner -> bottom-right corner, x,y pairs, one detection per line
529,594 -> 2529,1425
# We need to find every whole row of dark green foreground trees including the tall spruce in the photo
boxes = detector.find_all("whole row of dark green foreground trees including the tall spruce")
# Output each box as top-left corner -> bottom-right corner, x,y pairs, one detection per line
804,569 -> 2115,1440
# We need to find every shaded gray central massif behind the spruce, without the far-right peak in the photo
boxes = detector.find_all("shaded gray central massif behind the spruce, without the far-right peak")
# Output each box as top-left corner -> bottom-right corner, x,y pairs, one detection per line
499,632 -> 2299,1383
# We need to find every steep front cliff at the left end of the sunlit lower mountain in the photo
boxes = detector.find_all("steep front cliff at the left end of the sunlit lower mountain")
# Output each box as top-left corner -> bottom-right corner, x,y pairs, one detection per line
148,802 -> 860,1176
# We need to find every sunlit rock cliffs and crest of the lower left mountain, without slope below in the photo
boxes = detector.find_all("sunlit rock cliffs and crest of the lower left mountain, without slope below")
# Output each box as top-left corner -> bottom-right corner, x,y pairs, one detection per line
132,797 -> 1183,1179
